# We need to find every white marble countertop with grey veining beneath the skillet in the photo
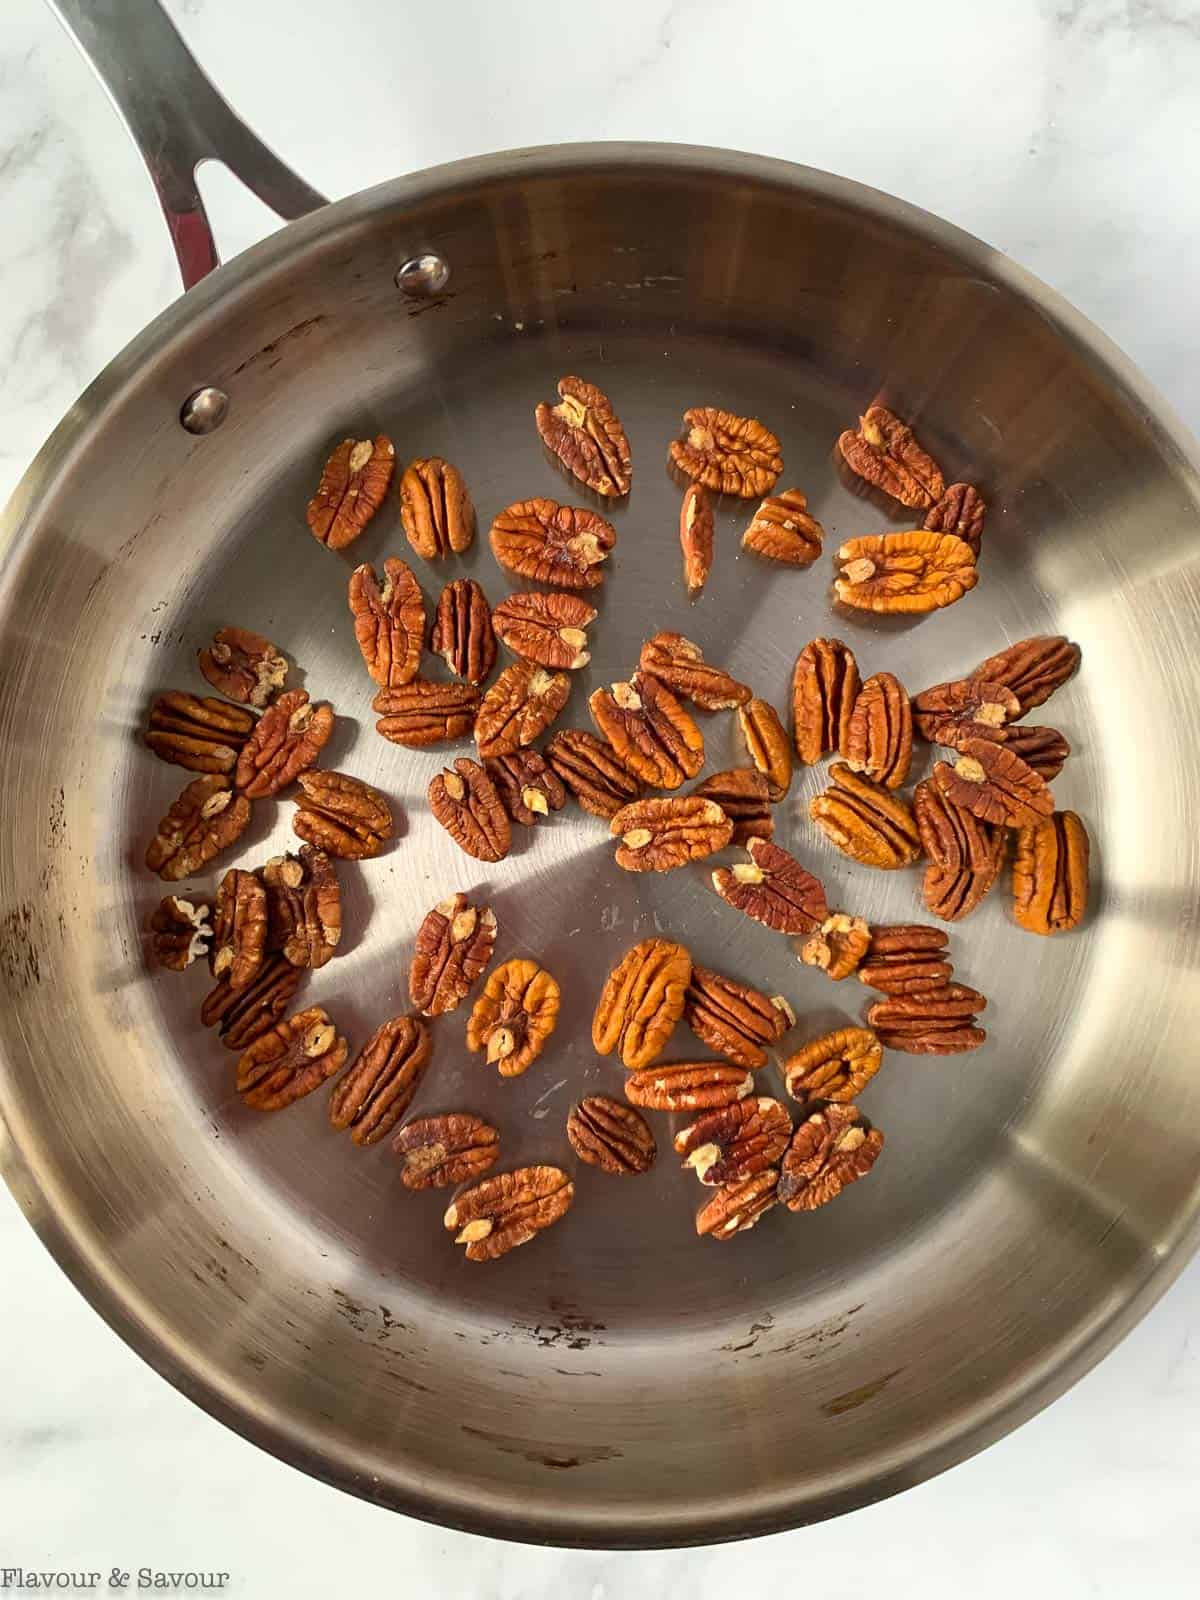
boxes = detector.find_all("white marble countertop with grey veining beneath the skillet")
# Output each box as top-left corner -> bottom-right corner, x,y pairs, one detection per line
0,0 -> 1200,1600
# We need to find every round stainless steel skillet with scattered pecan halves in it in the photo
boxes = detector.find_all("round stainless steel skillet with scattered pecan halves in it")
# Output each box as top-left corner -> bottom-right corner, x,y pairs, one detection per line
0,6 -> 1200,1546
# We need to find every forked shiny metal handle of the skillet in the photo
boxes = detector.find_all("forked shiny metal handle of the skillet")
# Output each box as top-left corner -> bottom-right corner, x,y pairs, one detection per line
50,0 -> 326,290
